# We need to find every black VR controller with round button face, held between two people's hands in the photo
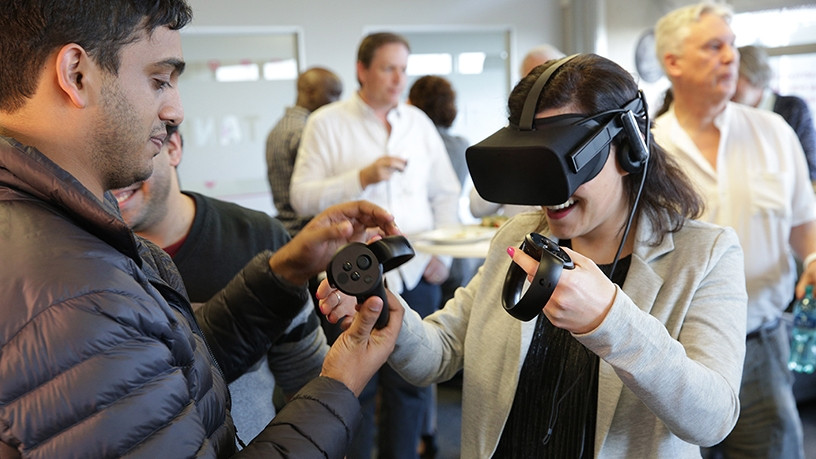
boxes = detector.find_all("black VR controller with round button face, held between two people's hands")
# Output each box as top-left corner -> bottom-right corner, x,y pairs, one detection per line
326,236 -> 414,329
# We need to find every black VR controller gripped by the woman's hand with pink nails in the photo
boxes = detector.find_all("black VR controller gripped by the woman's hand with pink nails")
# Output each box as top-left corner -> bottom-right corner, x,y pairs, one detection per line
502,233 -> 575,321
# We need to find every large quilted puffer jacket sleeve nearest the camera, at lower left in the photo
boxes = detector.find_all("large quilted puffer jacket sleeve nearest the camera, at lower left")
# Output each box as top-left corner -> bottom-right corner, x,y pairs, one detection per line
0,192 -> 233,458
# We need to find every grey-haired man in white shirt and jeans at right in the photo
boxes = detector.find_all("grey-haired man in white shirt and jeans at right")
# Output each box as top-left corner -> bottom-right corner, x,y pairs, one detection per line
654,3 -> 816,458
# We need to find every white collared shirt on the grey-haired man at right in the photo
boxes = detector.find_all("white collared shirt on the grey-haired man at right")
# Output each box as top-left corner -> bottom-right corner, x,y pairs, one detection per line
653,102 -> 816,332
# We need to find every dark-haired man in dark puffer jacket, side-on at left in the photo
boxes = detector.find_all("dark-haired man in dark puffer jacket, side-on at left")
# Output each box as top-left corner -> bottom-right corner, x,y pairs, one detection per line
0,0 -> 402,458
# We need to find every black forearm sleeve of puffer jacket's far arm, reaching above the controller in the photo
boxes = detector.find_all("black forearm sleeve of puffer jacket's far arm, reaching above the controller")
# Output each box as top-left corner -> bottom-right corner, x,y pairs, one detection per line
195,251 -> 309,382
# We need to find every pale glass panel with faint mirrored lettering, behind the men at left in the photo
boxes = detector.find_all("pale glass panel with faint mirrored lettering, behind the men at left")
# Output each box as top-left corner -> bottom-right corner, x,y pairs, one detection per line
178,28 -> 301,215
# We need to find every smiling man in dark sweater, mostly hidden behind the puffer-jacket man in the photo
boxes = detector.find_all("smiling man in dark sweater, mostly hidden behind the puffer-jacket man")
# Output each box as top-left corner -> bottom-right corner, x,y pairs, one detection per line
111,126 -> 329,439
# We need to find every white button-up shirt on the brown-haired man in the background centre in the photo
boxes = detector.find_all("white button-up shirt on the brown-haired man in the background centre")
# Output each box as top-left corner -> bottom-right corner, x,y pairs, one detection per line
291,92 -> 460,292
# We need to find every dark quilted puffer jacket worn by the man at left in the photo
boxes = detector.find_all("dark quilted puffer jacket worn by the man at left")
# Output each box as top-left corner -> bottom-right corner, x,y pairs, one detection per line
0,137 -> 359,458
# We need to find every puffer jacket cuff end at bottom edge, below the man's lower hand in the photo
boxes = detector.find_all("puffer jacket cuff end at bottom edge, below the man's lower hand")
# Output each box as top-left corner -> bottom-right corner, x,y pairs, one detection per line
236,376 -> 362,459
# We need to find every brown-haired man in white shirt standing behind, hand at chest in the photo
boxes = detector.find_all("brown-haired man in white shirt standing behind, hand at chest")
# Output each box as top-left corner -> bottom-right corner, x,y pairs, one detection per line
290,33 -> 460,457
